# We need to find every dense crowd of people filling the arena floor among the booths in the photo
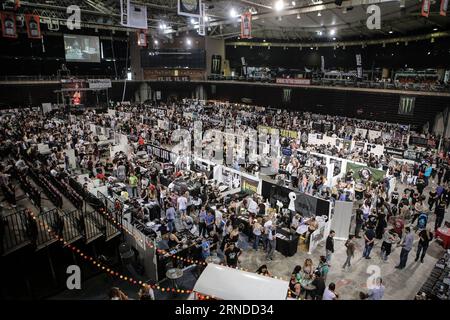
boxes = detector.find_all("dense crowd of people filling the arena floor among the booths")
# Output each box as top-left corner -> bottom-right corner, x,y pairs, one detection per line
0,101 -> 450,300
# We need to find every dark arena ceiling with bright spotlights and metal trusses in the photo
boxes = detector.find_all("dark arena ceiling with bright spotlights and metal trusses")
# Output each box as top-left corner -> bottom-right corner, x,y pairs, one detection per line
10,0 -> 450,41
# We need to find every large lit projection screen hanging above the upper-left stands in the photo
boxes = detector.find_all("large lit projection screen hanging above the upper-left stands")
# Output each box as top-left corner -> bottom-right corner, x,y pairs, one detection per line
64,34 -> 100,63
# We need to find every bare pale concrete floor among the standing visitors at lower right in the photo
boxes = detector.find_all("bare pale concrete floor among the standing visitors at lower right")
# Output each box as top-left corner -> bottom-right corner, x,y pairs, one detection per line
240,181 -> 450,300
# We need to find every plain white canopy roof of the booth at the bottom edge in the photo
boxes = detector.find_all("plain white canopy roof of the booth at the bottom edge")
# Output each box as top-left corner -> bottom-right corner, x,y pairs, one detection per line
190,263 -> 289,300
